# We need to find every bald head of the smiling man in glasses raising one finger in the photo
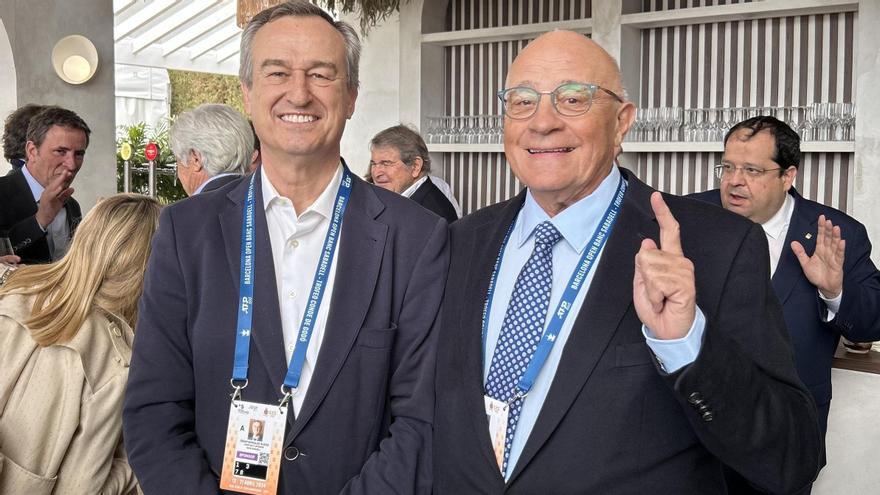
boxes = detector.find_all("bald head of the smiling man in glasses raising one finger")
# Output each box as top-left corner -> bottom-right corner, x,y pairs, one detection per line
504,31 -> 635,216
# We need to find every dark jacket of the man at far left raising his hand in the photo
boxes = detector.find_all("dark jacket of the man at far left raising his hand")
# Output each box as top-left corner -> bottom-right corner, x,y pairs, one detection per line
0,169 -> 82,265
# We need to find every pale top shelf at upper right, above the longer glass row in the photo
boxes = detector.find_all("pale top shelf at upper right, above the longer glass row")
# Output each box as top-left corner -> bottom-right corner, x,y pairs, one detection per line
620,0 -> 859,29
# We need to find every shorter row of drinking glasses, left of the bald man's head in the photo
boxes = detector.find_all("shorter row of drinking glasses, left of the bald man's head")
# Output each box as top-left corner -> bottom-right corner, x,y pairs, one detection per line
423,115 -> 504,144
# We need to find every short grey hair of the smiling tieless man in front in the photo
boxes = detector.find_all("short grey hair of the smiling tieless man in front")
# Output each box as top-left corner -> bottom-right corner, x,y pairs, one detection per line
238,1 -> 361,90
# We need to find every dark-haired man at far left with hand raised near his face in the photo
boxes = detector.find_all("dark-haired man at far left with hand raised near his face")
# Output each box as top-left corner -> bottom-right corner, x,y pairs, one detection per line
0,106 -> 92,264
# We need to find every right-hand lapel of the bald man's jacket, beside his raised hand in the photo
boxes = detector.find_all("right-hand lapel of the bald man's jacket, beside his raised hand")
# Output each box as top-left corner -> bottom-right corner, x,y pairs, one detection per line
508,169 -> 659,484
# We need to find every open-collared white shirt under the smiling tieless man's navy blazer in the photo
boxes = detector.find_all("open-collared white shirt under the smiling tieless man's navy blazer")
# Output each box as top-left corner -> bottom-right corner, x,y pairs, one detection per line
261,165 -> 345,414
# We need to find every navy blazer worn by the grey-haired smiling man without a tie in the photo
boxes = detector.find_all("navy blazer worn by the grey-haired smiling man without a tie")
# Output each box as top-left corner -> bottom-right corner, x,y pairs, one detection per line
124,168 -> 448,494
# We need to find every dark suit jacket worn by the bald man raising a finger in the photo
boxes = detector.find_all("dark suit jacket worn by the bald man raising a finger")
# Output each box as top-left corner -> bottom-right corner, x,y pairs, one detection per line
434,169 -> 819,495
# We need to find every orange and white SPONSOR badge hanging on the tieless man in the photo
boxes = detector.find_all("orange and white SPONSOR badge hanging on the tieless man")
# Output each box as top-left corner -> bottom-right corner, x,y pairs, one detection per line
220,400 -> 287,495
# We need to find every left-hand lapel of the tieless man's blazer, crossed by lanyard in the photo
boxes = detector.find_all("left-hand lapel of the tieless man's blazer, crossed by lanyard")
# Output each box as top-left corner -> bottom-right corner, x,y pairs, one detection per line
218,171 -> 293,404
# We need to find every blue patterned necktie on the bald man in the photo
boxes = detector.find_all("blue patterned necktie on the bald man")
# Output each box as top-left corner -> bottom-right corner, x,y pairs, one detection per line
486,221 -> 562,476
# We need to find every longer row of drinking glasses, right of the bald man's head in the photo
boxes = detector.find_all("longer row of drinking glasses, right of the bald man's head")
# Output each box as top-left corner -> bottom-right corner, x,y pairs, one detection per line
627,102 -> 856,142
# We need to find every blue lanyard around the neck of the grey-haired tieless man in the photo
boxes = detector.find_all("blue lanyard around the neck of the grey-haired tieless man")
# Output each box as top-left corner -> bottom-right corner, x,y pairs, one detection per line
232,167 -> 352,397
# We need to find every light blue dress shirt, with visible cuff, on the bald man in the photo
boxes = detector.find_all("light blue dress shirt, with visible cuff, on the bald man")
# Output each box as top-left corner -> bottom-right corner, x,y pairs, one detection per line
483,167 -> 705,478
